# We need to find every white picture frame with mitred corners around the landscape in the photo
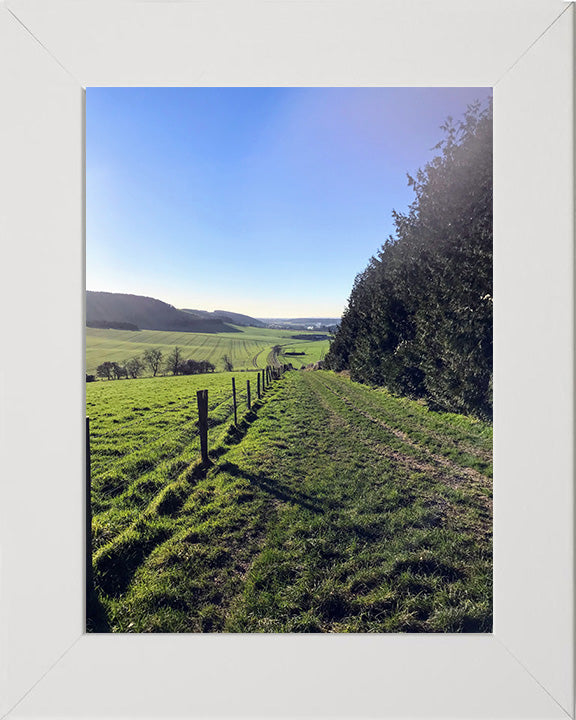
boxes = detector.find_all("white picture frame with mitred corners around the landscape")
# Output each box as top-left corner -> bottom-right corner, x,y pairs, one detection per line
0,0 -> 575,719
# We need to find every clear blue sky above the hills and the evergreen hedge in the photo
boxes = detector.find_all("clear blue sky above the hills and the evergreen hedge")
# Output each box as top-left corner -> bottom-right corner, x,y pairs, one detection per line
86,88 -> 491,317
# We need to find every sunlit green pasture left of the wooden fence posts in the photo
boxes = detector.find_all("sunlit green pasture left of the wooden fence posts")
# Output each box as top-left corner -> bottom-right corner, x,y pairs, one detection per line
86,373 -> 248,549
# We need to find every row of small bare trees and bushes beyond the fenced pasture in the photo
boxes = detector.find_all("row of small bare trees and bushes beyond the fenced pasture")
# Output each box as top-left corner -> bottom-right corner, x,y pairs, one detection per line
86,347 -> 217,382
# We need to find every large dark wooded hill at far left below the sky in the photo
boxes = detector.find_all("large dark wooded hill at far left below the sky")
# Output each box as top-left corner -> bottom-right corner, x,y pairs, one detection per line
86,290 -> 238,332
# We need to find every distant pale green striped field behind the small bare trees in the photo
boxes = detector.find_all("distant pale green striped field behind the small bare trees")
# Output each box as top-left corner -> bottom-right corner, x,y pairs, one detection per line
86,326 -> 329,374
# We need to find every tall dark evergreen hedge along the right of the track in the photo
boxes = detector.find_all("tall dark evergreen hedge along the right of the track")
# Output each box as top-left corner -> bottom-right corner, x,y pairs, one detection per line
326,101 -> 492,419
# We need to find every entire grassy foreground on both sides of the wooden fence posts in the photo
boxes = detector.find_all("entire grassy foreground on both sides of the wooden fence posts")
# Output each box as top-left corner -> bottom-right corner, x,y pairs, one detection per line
87,371 -> 492,632
